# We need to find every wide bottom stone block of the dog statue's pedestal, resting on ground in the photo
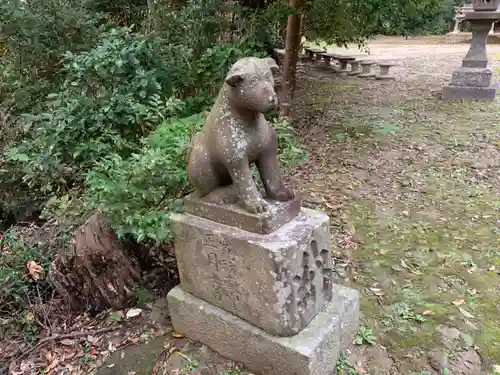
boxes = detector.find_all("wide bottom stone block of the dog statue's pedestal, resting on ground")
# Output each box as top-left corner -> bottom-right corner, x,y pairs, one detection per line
168,286 -> 359,375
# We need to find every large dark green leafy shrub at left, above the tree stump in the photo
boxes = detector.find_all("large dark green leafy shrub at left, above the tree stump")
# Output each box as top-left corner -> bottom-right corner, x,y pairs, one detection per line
6,28 -> 186,193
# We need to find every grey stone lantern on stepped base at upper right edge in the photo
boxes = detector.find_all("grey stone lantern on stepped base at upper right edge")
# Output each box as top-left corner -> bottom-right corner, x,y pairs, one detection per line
443,0 -> 500,100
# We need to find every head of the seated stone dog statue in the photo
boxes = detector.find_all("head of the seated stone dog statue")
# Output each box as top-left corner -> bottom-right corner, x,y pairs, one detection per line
225,57 -> 279,113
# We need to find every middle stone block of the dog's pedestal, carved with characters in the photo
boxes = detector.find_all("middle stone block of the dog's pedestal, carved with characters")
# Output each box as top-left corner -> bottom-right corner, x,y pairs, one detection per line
171,208 -> 332,336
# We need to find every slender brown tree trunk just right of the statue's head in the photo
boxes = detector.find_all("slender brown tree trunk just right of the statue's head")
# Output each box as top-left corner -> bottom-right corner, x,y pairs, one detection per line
281,0 -> 300,118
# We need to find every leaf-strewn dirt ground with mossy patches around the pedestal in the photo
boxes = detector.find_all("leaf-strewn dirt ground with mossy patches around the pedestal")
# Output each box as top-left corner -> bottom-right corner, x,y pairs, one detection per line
7,38 -> 500,375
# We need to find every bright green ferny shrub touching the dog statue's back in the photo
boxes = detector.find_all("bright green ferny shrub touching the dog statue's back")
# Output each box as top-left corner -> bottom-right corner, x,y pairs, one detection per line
85,114 -> 205,242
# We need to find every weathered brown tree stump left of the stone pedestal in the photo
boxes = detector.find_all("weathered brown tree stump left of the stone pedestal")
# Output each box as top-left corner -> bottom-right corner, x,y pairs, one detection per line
49,212 -> 141,310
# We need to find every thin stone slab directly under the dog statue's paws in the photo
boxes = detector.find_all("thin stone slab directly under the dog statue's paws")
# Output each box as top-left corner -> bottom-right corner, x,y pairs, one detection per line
184,188 -> 300,234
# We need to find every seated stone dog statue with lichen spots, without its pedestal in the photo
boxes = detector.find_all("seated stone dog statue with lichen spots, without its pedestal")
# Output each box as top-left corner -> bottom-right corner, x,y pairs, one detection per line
188,57 -> 294,214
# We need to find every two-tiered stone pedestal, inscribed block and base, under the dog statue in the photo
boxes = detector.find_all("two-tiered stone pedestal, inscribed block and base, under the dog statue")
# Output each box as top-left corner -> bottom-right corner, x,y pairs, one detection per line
168,194 -> 359,375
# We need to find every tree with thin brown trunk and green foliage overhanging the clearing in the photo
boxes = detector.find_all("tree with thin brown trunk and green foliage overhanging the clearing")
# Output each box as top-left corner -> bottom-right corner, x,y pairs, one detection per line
274,0 -> 465,115
